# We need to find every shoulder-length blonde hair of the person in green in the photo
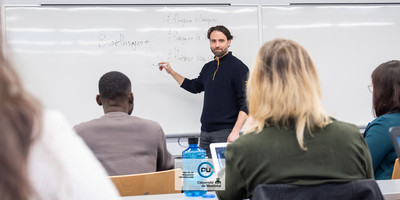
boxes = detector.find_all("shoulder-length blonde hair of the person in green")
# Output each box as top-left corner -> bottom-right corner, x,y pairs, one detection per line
245,39 -> 332,150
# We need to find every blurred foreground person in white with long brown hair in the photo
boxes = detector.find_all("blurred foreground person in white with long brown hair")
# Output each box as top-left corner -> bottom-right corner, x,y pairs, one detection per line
0,42 -> 119,200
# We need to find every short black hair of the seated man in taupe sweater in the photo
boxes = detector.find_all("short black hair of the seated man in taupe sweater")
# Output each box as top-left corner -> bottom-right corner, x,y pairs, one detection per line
99,71 -> 131,99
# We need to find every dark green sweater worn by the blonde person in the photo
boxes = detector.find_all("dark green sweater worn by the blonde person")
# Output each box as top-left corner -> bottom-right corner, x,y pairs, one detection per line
217,121 -> 373,200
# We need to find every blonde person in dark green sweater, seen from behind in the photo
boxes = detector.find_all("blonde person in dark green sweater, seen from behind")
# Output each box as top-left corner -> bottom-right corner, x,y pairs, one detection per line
217,39 -> 373,200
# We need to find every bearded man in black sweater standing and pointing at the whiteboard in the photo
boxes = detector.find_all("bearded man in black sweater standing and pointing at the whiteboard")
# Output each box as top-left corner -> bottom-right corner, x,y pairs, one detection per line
159,26 -> 249,157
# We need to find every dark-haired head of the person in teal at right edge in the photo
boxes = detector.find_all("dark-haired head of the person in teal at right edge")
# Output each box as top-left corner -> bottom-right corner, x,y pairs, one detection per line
371,60 -> 400,117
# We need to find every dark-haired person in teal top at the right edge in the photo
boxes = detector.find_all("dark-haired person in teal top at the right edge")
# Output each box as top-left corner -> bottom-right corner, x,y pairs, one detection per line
364,60 -> 400,180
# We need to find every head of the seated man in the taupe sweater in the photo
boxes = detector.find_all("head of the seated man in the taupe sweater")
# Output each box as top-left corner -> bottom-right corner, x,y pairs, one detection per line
96,71 -> 133,114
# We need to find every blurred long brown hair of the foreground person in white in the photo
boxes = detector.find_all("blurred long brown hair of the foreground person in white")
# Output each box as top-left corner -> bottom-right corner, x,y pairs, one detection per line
0,41 -> 41,200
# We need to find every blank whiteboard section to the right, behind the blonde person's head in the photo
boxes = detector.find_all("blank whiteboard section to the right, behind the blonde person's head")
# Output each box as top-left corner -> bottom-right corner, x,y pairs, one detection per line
262,5 -> 400,126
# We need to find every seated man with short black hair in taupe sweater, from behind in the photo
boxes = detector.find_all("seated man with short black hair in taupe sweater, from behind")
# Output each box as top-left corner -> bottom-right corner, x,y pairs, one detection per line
74,71 -> 174,176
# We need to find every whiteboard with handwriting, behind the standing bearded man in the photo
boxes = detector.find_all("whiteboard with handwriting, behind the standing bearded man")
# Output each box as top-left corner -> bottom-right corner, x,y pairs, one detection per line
5,6 -> 259,135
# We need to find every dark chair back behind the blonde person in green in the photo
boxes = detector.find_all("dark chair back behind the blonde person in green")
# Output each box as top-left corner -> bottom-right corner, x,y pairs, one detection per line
252,179 -> 384,200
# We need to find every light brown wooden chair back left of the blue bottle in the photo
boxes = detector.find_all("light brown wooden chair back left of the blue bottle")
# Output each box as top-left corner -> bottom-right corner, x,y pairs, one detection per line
110,169 -> 182,196
